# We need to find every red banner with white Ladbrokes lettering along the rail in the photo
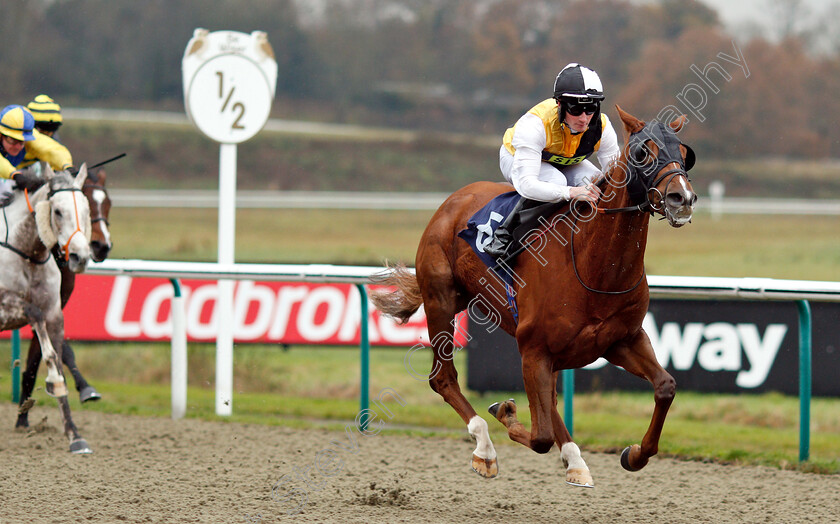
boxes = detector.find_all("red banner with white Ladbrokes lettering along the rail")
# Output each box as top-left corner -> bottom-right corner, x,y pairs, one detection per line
2,275 -> 446,346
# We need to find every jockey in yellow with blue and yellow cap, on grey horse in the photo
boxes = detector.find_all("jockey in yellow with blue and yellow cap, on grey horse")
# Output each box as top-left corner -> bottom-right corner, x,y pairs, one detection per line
0,105 -> 73,199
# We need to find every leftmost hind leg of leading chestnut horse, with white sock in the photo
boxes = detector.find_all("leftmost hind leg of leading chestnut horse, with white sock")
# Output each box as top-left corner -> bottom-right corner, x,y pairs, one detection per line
423,277 -> 499,478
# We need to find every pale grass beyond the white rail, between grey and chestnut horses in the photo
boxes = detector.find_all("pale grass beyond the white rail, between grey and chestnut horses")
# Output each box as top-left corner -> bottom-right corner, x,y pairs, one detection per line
111,207 -> 432,265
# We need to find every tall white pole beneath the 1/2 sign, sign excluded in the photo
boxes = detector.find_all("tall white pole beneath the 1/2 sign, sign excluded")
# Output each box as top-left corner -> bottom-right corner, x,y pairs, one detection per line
216,144 -> 236,415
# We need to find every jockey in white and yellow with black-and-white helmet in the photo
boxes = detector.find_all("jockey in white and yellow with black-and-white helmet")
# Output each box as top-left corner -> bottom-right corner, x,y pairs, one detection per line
484,63 -> 619,257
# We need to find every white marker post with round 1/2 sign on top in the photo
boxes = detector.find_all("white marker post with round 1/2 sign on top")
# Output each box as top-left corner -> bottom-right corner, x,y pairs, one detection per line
181,27 -> 277,415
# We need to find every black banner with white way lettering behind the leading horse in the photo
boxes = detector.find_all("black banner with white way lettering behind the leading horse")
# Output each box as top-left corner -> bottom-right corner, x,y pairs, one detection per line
466,300 -> 840,396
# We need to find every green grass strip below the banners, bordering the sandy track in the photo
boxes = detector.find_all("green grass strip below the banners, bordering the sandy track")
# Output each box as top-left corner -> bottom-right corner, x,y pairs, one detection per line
8,343 -> 840,473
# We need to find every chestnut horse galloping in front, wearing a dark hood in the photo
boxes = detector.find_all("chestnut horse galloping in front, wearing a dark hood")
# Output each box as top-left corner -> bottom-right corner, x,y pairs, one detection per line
371,106 -> 697,487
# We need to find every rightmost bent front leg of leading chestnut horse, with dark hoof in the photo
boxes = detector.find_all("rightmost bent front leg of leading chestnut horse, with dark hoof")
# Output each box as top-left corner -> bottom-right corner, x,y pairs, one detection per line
604,329 -> 677,471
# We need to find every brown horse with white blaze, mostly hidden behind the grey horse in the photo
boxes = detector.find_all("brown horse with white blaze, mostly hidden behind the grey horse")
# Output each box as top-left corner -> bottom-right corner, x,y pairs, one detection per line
15,169 -> 113,428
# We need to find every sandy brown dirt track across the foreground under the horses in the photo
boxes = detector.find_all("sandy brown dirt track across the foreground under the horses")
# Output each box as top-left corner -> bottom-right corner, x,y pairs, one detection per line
0,402 -> 840,524
